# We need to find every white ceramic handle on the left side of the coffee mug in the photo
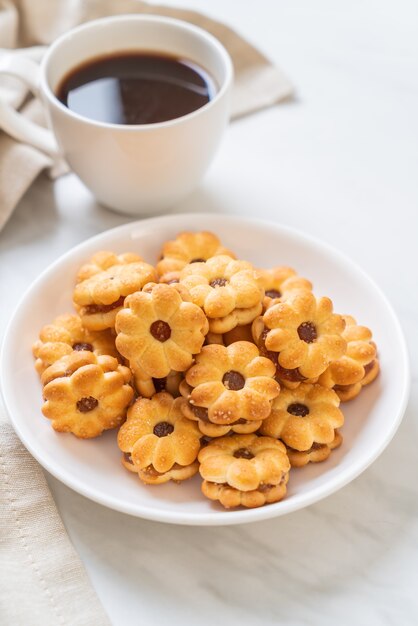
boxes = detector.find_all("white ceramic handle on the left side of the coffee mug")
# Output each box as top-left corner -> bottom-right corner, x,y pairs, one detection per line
0,54 -> 60,158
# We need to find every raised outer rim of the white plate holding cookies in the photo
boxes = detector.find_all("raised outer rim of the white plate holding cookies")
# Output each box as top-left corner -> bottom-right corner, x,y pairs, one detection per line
0,212 -> 411,526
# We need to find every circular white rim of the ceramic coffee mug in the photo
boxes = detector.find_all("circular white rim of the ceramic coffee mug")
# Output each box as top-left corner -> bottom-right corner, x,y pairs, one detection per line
40,13 -> 234,132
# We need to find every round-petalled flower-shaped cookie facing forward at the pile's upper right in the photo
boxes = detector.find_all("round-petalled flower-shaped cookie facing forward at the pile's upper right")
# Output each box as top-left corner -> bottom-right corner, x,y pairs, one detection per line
262,291 -> 346,378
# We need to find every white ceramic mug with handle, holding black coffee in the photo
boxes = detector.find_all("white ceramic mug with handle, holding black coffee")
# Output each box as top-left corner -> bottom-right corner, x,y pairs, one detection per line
0,15 -> 233,215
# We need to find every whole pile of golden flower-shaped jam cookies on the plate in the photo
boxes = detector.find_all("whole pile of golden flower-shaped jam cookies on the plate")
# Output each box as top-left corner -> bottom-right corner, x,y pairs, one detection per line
33,232 -> 379,508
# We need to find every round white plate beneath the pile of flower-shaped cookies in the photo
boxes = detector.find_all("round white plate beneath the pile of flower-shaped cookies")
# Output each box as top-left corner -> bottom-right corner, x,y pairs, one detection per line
1,214 -> 409,525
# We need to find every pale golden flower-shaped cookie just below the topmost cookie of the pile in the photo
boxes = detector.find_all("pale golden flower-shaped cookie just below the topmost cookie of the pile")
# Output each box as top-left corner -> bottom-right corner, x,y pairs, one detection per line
180,255 -> 264,333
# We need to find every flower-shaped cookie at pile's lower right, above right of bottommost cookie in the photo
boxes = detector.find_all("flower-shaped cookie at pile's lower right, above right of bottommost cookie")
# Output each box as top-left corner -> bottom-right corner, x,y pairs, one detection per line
260,383 -> 344,452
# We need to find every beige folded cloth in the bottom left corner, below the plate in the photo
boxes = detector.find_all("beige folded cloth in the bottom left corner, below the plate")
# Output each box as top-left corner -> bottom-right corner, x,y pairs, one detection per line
0,399 -> 110,626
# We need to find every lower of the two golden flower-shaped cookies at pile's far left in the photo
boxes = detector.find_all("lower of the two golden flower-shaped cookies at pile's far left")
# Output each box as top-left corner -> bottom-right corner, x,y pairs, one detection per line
42,351 -> 133,439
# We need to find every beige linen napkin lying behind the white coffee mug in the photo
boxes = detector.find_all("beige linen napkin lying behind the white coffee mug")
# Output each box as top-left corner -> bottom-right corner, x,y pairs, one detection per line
0,0 -> 292,230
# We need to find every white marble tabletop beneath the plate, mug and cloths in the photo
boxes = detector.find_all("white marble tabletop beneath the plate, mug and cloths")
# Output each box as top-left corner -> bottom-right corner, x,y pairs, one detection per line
0,0 -> 418,626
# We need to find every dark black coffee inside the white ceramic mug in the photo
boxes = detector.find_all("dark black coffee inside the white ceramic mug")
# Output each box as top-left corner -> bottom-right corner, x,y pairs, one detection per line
57,52 -> 216,124
